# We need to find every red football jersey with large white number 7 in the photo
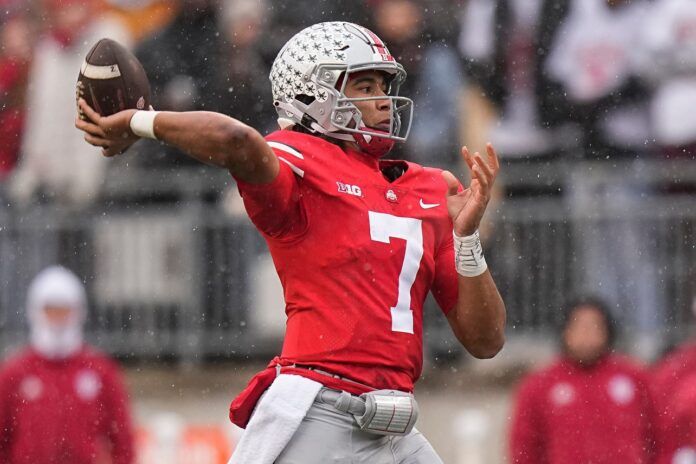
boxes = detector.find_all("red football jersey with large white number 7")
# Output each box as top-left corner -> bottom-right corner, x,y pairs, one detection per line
239,130 -> 458,391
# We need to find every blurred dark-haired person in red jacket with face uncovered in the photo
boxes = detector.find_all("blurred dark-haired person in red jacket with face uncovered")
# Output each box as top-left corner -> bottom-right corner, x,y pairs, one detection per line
510,299 -> 654,464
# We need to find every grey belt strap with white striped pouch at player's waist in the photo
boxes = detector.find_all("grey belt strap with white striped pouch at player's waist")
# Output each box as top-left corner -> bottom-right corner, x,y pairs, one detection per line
315,387 -> 418,435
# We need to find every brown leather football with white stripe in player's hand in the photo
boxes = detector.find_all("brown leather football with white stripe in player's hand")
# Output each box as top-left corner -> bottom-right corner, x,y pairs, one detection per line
76,39 -> 150,119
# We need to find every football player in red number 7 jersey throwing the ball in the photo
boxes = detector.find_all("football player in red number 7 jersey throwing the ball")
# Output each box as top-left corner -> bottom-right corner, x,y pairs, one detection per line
76,22 -> 505,463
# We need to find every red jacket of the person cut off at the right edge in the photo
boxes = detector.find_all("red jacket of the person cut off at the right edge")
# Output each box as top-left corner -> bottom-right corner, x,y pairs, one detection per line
652,344 -> 696,464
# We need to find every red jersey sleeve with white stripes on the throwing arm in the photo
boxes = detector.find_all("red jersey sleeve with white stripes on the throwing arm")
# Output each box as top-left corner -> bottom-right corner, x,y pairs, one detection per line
237,142 -> 307,240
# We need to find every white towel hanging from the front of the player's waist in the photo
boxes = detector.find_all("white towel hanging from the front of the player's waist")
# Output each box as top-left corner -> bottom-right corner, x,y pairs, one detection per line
227,374 -> 322,464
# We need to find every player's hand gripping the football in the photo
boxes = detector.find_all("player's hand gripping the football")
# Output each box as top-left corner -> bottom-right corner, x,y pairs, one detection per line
75,98 -> 138,156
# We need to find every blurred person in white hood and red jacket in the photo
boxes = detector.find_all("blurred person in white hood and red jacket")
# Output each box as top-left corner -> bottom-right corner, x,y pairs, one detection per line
0,266 -> 134,464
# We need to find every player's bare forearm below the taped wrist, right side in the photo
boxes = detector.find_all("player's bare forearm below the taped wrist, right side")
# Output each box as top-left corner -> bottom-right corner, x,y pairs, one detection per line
447,271 -> 506,359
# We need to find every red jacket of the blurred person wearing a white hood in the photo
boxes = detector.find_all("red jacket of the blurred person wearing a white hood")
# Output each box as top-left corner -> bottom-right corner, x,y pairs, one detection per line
0,348 -> 134,464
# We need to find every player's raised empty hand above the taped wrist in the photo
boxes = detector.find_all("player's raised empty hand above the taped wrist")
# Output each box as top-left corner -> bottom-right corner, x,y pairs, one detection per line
442,143 -> 500,237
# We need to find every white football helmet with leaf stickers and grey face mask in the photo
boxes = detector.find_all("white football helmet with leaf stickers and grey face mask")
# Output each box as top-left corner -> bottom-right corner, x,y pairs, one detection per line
270,21 -> 413,156
